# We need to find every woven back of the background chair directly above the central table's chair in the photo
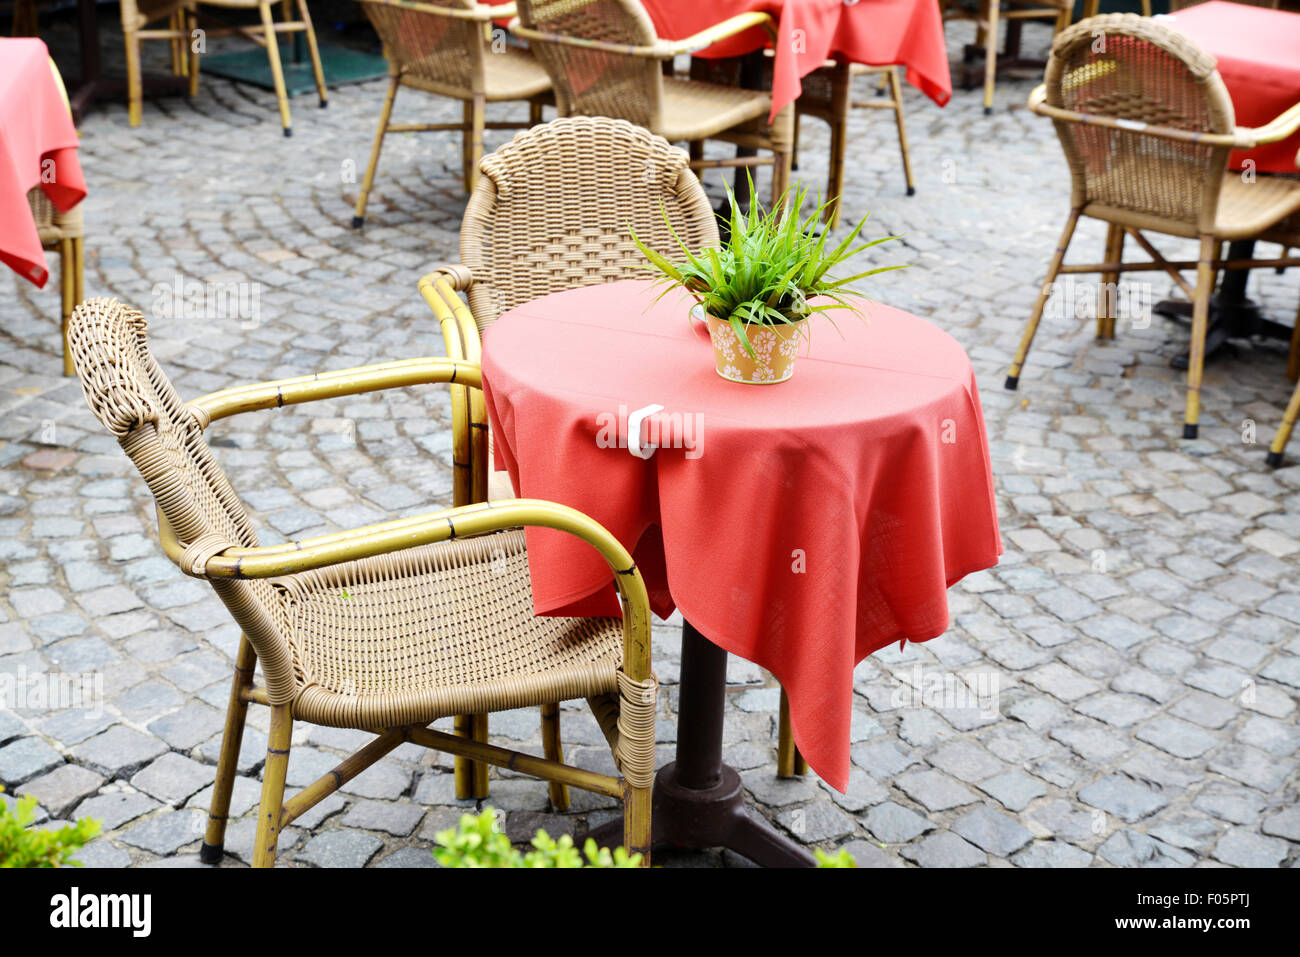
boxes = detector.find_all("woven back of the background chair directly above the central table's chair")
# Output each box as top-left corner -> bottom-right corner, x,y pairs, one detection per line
517,0 -> 663,130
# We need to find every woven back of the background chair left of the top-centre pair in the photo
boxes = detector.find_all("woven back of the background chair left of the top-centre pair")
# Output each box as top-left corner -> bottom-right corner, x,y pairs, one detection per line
359,0 -> 491,96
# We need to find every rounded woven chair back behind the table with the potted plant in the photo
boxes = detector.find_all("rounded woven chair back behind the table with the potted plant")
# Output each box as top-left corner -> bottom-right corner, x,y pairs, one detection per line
460,117 -> 718,332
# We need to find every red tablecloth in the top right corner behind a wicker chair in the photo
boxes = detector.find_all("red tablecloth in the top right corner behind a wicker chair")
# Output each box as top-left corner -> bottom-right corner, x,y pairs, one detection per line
1162,0 -> 1300,173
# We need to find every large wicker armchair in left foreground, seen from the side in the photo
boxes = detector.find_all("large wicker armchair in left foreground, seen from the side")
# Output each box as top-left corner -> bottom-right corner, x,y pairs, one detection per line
69,299 -> 657,867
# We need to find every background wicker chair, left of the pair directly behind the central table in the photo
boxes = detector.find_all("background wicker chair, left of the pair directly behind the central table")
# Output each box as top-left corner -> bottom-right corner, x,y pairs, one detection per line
352,0 -> 551,228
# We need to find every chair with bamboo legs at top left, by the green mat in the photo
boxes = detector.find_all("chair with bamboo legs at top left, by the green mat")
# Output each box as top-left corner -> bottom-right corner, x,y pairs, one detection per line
122,0 -> 329,137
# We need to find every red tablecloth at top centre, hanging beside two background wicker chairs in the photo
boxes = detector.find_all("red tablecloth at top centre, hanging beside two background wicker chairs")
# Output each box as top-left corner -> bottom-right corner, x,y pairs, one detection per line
490,0 -> 953,122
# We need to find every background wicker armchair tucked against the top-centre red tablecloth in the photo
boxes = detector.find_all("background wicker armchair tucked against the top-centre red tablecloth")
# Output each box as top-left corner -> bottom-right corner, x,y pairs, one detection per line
512,0 -> 794,203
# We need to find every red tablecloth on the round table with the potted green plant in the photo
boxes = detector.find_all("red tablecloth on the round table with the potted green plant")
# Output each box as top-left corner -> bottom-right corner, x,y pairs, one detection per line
484,281 -> 1002,791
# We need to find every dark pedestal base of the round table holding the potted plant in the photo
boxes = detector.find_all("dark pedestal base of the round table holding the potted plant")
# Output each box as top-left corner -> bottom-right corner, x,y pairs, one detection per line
592,622 -> 816,867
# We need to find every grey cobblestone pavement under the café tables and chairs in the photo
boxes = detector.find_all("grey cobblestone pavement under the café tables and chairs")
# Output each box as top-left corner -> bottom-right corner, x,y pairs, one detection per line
0,16 -> 1300,867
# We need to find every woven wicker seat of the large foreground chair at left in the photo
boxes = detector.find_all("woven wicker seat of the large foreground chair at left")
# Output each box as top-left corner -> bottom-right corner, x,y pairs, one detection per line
281,529 -> 623,728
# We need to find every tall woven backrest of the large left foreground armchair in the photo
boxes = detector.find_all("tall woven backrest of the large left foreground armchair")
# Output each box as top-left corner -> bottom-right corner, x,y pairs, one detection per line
68,299 -> 294,703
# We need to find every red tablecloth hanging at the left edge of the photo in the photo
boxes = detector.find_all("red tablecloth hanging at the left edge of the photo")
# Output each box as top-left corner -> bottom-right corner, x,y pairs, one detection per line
0,38 -> 86,286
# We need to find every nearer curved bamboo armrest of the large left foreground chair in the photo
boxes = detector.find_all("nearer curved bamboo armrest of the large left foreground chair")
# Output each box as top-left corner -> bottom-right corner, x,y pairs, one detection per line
159,498 -> 650,681
